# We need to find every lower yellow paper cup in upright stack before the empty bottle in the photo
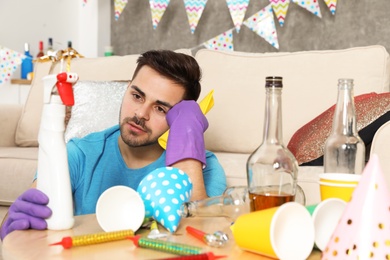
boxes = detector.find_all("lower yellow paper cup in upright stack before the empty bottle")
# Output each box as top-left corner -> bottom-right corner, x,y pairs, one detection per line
319,181 -> 357,202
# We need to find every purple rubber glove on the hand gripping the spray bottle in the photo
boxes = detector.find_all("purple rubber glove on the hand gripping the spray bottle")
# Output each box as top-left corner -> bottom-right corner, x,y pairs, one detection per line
0,188 -> 52,240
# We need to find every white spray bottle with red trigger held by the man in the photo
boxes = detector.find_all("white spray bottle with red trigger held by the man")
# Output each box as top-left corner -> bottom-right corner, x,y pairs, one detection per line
37,72 -> 78,230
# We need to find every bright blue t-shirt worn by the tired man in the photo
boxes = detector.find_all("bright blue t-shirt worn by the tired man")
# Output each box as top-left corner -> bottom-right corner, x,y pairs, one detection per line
67,125 -> 226,215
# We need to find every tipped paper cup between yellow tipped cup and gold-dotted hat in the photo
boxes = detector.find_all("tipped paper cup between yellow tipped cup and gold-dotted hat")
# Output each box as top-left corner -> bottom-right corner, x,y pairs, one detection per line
306,198 -> 347,251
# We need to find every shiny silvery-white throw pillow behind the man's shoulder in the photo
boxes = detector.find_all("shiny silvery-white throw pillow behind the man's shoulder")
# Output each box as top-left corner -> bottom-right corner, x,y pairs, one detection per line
65,81 -> 129,142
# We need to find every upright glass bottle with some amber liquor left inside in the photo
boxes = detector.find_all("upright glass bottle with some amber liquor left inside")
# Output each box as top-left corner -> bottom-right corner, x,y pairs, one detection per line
246,77 -> 298,212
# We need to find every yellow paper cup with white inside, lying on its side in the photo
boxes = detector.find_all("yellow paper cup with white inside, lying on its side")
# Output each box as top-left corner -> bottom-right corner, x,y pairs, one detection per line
231,202 -> 314,260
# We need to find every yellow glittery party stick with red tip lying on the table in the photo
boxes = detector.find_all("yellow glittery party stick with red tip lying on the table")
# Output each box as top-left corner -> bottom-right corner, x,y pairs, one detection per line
49,229 -> 134,249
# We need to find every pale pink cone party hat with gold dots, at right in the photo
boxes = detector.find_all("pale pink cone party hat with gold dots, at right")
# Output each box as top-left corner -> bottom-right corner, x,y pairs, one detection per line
322,154 -> 390,260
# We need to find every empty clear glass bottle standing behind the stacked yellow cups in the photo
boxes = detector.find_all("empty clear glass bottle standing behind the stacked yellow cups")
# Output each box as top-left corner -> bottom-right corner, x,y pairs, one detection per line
324,79 -> 365,174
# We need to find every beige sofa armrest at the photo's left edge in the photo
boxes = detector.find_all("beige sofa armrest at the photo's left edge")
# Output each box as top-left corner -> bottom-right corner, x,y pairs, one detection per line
0,104 -> 23,147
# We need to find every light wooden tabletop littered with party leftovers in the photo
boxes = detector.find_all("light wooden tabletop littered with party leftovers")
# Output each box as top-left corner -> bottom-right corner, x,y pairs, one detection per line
2,214 -> 321,260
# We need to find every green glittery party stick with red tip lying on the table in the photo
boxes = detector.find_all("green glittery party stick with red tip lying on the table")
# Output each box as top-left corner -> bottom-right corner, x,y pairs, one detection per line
128,235 -> 204,255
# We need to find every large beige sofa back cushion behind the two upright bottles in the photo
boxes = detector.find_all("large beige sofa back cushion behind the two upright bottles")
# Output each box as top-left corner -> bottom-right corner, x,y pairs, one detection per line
195,46 -> 390,153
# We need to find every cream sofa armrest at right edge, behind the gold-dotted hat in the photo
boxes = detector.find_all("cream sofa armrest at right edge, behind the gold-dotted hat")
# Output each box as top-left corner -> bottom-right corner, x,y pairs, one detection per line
366,121 -> 390,188
